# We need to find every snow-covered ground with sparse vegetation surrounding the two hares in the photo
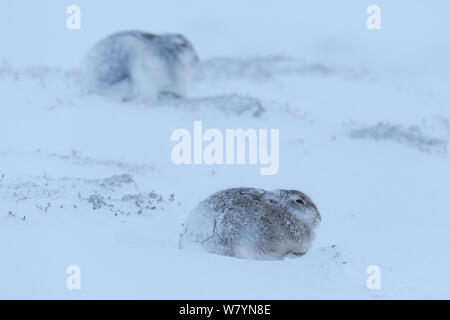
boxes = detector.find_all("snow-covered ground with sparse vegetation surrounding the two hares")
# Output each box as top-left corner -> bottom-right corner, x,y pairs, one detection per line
0,0 -> 450,299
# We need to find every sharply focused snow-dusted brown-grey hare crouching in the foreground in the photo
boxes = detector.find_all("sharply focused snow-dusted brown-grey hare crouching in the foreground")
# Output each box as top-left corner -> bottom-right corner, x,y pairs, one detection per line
180,188 -> 321,260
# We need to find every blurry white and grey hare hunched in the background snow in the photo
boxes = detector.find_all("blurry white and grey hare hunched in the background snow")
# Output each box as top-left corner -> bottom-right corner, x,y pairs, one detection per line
81,31 -> 198,101
